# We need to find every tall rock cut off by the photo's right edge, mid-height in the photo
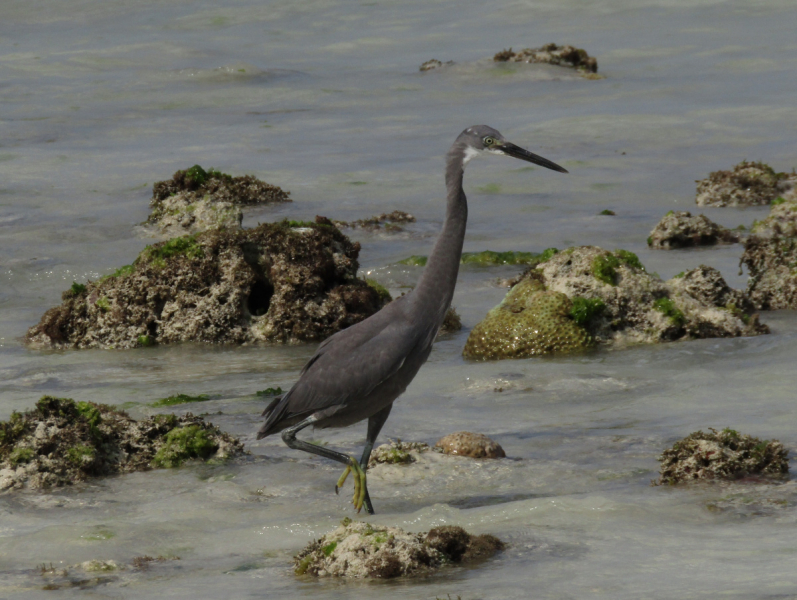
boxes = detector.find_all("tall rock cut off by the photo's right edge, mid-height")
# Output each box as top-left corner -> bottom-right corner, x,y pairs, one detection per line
740,191 -> 797,310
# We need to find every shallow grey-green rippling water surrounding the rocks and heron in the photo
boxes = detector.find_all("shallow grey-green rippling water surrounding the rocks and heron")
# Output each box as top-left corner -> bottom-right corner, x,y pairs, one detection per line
0,0 -> 797,600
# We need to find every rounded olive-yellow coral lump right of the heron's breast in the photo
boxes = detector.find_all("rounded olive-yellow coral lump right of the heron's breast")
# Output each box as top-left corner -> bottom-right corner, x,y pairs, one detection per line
462,278 -> 593,360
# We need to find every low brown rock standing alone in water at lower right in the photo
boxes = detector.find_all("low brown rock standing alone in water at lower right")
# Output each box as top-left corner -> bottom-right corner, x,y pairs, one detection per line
653,429 -> 789,485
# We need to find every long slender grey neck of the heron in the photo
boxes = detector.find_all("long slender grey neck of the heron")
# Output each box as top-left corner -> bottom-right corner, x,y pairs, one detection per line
413,146 -> 468,327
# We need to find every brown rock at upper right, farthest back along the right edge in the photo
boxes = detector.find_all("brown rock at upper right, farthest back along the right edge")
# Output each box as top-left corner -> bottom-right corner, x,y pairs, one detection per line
695,161 -> 797,206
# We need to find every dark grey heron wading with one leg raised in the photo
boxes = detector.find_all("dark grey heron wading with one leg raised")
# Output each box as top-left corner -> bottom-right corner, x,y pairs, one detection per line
257,125 -> 567,514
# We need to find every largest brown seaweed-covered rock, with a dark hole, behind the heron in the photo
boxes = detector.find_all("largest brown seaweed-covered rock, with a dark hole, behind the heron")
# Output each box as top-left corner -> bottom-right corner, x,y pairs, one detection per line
26,221 -> 385,348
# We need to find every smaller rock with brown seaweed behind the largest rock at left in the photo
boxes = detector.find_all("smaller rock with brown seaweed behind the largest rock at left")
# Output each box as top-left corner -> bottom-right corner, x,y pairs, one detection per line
147,165 -> 291,235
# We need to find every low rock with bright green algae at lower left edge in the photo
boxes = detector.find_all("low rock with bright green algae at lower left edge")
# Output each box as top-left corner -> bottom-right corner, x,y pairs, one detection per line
0,396 -> 244,491
